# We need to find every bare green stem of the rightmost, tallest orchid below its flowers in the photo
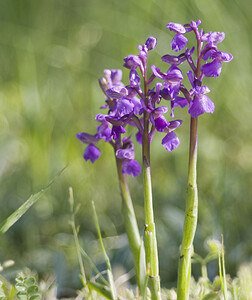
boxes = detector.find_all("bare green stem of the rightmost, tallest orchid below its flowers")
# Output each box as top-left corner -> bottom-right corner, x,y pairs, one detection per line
178,118 -> 198,300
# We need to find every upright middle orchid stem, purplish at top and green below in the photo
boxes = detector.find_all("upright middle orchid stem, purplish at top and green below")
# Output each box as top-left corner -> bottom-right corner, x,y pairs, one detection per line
142,112 -> 161,300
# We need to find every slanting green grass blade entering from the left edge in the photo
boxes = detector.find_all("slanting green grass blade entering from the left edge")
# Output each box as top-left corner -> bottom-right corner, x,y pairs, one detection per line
0,166 -> 67,236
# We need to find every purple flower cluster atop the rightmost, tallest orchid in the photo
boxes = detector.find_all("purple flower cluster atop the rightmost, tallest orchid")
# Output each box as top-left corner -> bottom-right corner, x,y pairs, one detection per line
160,20 -> 233,118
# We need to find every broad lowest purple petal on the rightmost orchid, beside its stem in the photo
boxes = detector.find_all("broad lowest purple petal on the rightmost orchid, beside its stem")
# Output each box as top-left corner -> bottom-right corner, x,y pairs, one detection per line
188,95 -> 215,118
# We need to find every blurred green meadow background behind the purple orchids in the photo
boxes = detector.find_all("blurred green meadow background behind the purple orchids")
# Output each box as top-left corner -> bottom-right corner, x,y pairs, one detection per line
0,0 -> 252,287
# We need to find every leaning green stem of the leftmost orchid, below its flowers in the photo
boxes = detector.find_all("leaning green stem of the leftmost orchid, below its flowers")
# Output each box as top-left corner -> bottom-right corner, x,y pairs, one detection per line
116,158 -> 146,295
